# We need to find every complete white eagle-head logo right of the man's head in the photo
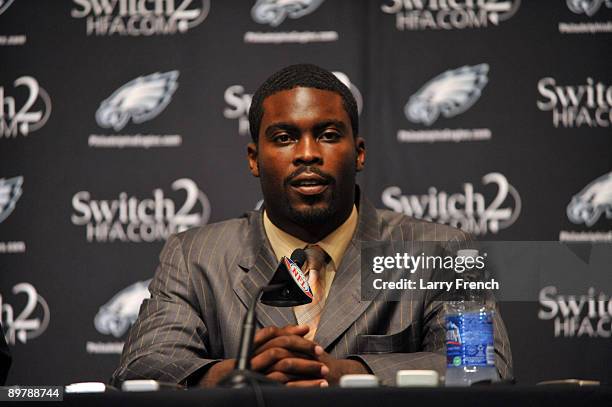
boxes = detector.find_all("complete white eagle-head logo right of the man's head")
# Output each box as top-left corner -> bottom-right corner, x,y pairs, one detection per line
404,64 -> 489,126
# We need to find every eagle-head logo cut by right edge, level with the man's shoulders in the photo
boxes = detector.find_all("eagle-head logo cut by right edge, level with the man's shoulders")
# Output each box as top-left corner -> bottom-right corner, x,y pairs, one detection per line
567,172 -> 612,226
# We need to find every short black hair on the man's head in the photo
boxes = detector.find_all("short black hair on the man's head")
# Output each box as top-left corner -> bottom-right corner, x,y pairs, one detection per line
249,64 -> 359,143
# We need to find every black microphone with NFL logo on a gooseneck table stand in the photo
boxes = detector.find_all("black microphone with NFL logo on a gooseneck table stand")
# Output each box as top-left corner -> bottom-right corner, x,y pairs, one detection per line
219,249 -> 312,388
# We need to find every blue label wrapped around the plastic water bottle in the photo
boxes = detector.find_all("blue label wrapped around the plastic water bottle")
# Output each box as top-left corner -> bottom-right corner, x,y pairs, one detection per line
446,312 -> 495,367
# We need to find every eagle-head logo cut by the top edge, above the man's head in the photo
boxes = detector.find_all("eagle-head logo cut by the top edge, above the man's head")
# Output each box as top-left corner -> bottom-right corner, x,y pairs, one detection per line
251,0 -> 323,27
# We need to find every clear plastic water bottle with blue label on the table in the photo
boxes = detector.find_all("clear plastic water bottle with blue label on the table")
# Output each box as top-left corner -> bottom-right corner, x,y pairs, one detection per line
445,250 -> 499,386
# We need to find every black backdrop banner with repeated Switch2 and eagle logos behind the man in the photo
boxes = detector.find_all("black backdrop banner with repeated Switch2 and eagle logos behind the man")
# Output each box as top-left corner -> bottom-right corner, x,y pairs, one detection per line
0,0 -> 612,384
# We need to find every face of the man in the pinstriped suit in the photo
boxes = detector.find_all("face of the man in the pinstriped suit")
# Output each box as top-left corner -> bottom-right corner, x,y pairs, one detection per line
248,87 -> 365,225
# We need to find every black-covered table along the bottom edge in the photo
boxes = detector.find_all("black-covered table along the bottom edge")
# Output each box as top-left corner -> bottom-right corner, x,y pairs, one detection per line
7,386 -> 612,407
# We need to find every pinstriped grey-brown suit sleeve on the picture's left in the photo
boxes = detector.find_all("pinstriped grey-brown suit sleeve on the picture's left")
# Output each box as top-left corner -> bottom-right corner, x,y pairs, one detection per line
111,235 -> 218,386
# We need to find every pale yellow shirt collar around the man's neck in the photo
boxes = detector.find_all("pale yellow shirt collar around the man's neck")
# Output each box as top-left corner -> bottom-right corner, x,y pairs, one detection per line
263,205 -> 358,268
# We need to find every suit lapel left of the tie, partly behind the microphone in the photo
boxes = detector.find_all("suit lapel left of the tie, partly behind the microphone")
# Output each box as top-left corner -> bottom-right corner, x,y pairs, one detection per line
233,211 -> 297,327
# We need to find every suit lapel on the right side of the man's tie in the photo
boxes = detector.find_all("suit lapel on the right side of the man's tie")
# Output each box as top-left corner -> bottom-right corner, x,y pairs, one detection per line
314,194 -> 380,349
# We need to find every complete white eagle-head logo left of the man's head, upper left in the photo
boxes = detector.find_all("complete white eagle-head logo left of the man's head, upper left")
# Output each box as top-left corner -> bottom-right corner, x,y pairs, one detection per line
96,71 -> 179,131
